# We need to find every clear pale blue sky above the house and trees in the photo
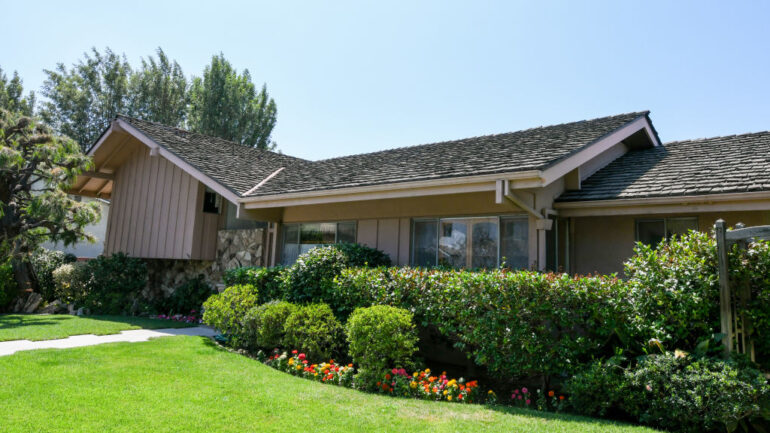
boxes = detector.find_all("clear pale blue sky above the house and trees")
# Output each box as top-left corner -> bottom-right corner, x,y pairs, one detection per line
0,0 -> 770,159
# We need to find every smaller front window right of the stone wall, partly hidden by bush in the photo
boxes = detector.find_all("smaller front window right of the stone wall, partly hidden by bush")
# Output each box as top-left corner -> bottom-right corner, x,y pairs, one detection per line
281,221 -> 356,265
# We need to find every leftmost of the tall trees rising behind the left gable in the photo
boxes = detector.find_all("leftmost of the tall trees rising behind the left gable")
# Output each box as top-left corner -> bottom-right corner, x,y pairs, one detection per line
40,48 -> 131,150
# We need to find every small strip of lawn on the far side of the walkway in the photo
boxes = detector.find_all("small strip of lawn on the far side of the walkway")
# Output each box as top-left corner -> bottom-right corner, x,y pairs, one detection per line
0,314 -> 194,341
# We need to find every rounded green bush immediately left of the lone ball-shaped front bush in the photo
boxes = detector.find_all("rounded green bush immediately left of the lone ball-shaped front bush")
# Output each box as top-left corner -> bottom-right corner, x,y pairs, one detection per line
284,304 -> 344,361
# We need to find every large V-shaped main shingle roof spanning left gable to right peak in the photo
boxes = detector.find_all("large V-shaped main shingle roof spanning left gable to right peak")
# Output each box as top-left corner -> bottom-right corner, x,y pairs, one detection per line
119,111 -> 649,196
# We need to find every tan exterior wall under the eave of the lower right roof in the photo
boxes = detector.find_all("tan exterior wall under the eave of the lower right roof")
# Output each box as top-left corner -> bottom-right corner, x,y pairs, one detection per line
570,211 -> 770,274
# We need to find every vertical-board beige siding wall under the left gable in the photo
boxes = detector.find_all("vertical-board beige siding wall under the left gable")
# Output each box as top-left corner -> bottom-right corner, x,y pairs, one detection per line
104,143 -> 222,260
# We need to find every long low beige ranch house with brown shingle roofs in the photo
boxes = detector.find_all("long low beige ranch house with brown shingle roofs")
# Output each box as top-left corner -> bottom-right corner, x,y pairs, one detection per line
73,112 -> 770,282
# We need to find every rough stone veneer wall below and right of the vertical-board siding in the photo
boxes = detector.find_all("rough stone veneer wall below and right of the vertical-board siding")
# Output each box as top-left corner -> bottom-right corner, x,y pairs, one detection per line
145,229 -> 267,296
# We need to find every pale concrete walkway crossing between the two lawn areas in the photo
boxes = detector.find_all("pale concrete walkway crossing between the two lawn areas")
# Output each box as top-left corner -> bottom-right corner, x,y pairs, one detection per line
0,326 -> 218,356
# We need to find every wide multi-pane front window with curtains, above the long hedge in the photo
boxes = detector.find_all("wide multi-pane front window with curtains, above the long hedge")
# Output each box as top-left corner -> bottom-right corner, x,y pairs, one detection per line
412,217 -> 529,268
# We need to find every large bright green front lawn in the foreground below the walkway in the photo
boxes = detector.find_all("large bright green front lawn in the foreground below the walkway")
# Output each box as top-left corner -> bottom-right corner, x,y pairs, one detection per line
0,337 -> 653,433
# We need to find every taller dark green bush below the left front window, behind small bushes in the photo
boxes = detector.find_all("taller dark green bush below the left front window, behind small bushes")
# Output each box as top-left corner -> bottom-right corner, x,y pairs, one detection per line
280,244 -> 390,319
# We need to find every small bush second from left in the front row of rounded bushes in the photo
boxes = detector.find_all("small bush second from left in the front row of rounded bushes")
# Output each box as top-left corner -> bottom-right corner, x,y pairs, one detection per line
244,301 -> 298,349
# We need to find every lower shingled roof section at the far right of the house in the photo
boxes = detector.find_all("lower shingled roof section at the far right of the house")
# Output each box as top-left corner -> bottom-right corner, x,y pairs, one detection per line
557,132 -> 770,202
